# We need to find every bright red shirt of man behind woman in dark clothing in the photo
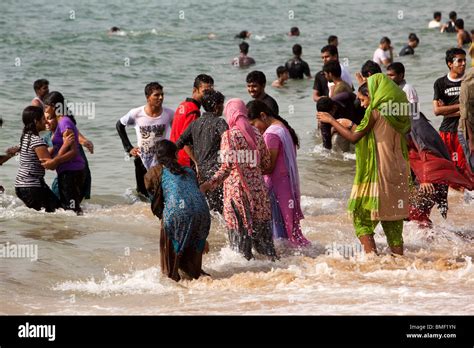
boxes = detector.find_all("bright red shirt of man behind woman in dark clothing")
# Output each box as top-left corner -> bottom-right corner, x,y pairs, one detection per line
170,98 -> 201,167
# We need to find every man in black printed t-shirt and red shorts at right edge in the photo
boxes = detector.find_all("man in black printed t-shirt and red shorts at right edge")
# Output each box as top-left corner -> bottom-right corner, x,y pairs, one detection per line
433,48 -> 466,171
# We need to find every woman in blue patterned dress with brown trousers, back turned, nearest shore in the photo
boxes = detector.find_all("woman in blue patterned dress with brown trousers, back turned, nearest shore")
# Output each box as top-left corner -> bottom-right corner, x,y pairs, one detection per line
145,140 -> 211,281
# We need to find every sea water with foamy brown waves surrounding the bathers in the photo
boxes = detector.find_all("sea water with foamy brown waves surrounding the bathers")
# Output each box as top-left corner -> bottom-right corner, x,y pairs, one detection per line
0,0 -> 474,315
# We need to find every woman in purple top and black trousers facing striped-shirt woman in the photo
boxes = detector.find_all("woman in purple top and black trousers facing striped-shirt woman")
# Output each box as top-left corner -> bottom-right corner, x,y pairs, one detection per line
43,92 -> 86,215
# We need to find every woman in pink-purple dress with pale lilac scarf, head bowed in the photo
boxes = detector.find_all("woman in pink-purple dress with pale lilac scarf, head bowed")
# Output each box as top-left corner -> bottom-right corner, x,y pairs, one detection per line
247,100 -> 310,246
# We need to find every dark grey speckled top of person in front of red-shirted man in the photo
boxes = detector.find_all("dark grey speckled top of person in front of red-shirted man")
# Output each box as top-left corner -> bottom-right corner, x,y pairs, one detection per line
176,112 -> 229,213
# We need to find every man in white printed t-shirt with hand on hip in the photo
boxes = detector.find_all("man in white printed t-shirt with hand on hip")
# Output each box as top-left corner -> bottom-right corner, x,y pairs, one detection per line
116,82 -> 174,196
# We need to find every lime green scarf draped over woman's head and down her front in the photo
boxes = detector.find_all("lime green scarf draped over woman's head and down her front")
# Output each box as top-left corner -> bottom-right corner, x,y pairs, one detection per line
348,73 -> 410,220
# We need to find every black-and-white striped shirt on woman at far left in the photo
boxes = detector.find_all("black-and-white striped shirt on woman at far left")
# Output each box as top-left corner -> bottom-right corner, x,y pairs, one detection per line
15,134 -> 46,187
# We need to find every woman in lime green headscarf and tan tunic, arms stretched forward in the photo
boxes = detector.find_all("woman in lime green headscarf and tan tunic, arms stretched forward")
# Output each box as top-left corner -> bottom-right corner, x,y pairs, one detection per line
317,73 -> 410,255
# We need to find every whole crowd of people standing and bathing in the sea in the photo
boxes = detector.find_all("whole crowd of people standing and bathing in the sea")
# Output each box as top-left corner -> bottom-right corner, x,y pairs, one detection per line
0,12 -> 474,280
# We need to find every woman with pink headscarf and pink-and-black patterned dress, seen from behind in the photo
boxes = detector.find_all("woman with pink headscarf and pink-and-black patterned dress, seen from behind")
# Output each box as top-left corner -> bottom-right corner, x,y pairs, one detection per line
201,99 -> 277,260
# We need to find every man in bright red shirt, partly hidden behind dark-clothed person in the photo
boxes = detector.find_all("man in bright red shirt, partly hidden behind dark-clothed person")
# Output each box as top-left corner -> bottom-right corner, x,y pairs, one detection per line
170,74 -> 214,167
